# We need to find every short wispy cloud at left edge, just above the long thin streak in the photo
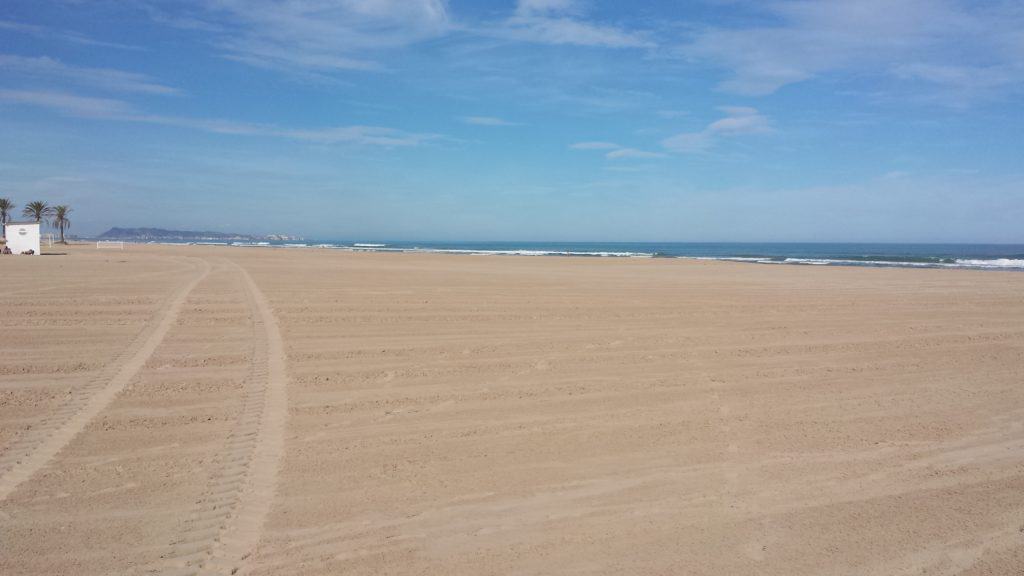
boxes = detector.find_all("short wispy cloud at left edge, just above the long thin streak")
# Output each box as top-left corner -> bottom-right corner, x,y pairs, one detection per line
0,54 -> 180,94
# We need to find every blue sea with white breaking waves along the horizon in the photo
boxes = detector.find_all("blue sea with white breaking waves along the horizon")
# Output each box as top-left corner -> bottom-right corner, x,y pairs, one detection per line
159,240 -> 1024,271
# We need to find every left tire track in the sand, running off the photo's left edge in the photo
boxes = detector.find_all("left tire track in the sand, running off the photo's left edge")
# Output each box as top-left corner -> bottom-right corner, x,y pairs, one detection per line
0,259 -> 210,502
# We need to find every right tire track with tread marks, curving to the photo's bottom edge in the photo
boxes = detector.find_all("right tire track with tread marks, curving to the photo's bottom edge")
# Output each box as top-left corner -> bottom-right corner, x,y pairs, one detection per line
155,264 -> 288,576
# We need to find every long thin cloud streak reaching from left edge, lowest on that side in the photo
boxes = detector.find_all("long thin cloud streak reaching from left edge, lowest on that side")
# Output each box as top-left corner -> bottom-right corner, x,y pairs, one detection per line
0,89 -> 442,148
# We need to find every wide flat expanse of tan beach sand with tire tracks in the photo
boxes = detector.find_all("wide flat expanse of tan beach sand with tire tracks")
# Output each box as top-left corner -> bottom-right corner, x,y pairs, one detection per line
0,246 -> 1024,575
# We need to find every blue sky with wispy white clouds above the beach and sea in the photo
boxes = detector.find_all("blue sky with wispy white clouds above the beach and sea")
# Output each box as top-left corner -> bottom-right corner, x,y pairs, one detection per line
0,0 -> 1024,243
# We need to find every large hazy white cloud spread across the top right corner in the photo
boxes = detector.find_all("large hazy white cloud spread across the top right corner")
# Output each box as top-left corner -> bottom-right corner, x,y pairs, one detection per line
680,0 -> 1024,95
